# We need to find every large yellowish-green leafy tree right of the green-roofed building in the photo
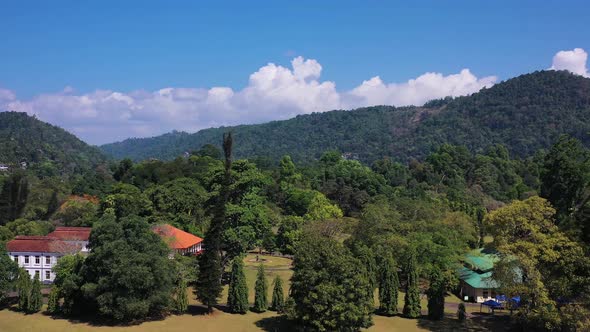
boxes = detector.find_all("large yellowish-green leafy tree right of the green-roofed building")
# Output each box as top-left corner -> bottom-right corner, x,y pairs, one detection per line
485,196 -> 590,329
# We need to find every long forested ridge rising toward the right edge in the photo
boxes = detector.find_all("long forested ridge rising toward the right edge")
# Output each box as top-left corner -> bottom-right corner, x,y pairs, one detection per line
101,71 -> 590,162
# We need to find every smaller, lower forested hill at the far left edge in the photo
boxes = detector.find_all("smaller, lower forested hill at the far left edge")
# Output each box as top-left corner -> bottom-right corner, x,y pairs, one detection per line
0,112 -> 106,174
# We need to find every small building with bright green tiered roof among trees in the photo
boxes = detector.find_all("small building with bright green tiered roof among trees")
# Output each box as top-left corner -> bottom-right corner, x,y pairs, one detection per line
458,248 -> 500,303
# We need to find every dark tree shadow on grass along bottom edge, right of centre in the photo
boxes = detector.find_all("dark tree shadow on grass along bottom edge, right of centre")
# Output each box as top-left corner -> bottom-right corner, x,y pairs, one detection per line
418,314 -> 511,332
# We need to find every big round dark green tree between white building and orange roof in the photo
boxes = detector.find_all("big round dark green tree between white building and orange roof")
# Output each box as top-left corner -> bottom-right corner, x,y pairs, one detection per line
81,216 -> 175,321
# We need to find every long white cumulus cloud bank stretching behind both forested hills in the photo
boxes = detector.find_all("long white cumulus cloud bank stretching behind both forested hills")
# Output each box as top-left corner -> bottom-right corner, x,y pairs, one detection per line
0,57 -> 497,144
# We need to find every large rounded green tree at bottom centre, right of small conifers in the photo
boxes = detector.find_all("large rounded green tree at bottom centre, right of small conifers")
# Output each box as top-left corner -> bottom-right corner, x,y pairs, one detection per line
289,233 -> 373,331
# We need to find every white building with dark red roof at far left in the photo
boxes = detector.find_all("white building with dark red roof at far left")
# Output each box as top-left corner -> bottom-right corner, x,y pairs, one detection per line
6,227 -> 91,283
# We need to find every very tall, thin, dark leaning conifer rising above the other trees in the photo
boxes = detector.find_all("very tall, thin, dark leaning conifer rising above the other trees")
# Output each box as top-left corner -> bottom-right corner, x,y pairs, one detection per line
196,133 -> 232,312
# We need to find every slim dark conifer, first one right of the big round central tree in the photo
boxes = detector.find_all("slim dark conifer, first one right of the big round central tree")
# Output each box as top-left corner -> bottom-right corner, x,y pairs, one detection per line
379,255 -> 399,316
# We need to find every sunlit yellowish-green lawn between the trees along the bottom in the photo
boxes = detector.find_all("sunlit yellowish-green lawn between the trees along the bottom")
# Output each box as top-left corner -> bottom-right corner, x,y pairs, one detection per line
0,254 -> 508,332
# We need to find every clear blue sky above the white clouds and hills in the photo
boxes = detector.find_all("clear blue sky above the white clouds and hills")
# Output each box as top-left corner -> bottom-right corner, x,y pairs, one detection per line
0,0 -> 590,143
